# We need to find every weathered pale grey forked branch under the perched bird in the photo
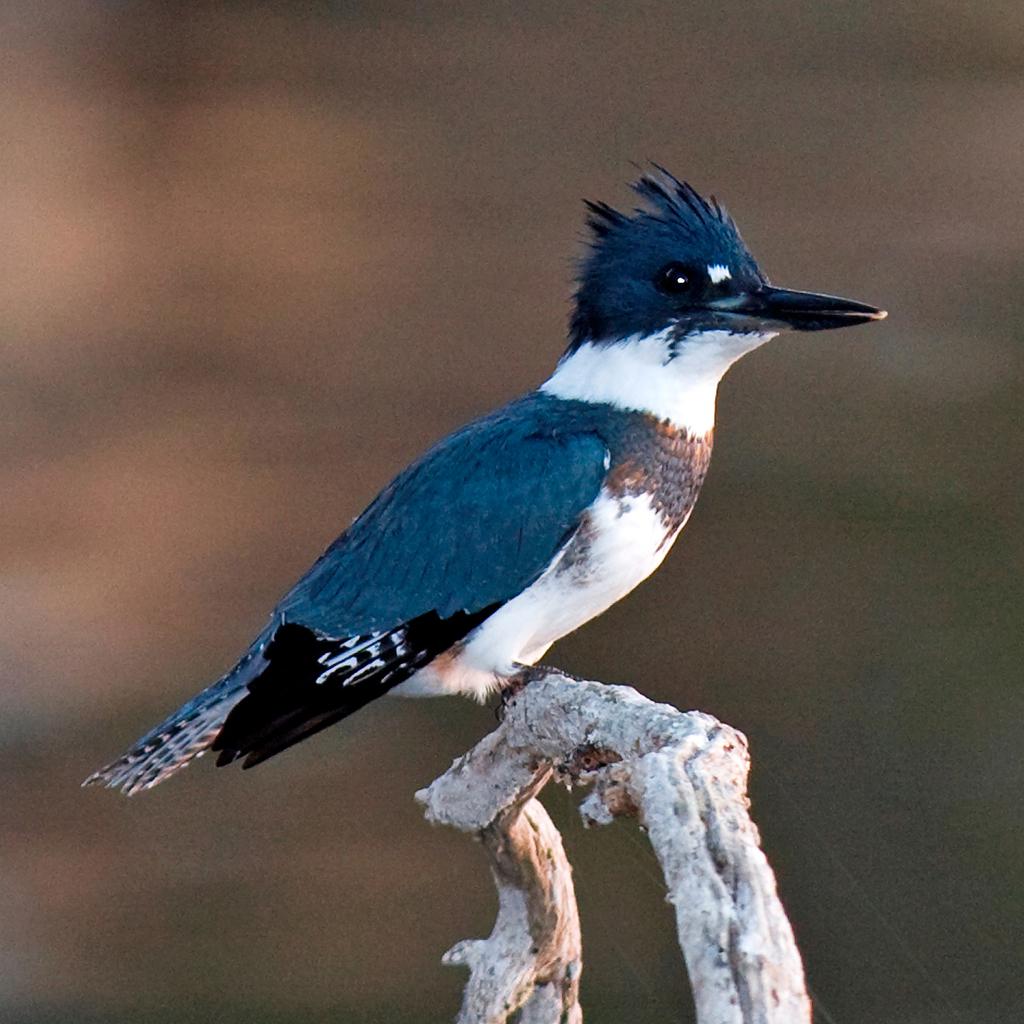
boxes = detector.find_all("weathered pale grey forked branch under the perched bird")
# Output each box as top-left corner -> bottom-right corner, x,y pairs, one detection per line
417,670 -> 811,1024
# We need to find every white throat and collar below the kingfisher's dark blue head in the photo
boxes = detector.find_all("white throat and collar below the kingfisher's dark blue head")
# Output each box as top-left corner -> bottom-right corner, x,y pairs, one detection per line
541,328 -> 776,435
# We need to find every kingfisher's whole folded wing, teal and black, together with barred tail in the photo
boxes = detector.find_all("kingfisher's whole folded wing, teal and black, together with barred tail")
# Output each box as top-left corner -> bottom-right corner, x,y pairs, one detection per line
89,394 -> 607,793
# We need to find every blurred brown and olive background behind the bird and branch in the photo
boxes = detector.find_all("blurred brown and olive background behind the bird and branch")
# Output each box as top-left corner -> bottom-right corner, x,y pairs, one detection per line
0,0 -> 1024,1024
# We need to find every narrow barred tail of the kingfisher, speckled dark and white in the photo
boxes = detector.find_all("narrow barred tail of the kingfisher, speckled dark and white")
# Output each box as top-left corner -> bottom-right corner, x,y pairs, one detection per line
82,645 -> 266,797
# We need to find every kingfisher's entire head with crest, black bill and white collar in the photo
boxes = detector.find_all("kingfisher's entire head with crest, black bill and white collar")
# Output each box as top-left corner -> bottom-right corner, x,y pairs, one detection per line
541,168 -> 886,435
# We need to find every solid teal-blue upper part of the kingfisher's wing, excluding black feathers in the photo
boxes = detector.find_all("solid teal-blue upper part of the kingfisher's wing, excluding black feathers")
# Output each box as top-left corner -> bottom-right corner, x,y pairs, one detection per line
278,396 -> 607,637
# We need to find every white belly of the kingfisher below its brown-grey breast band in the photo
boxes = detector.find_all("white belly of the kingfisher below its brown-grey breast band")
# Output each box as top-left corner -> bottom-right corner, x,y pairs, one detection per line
391,490 -> 682,700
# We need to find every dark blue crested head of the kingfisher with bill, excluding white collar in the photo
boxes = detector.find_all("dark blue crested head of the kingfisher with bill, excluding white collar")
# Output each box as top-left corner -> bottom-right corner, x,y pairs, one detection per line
569,167 -> 886,354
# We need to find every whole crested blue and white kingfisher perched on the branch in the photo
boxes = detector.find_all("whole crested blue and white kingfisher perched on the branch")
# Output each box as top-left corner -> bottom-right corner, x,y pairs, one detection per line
85,167 -> 886,794
